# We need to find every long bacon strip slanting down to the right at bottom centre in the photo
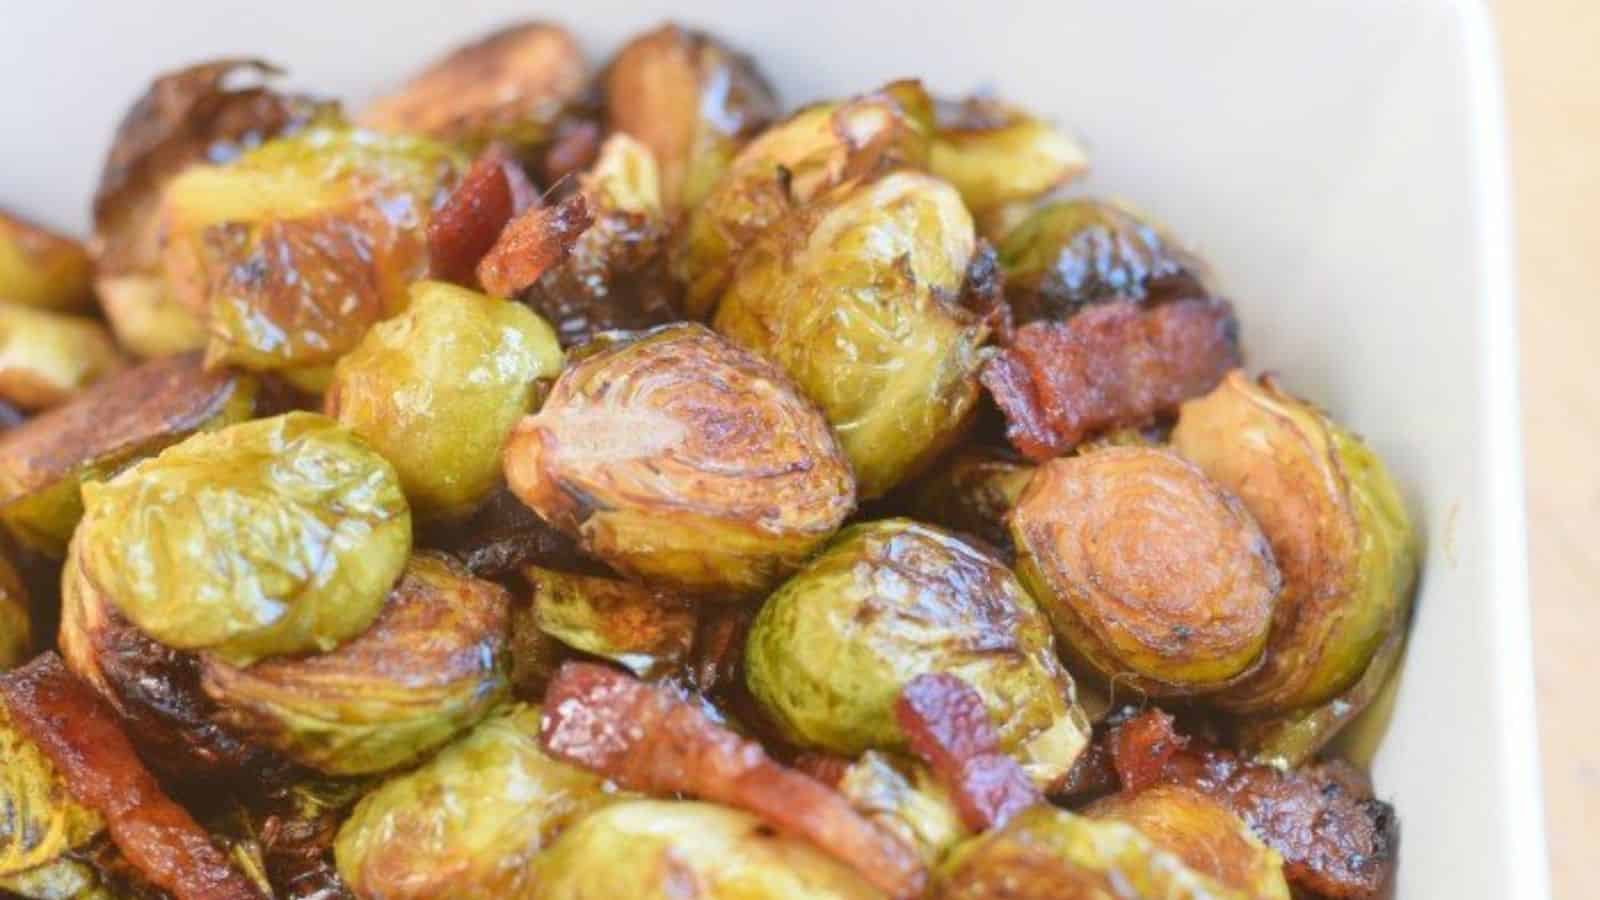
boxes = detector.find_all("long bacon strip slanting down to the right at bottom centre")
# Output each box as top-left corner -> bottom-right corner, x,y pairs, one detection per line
539,663 -> 926,898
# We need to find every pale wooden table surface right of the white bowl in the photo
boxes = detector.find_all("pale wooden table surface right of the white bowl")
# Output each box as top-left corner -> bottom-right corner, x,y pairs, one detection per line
1494,0 -> 1600,883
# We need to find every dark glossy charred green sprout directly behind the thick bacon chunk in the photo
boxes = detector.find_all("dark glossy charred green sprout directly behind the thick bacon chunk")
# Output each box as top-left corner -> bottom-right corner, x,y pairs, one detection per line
998,199 -> 1210,323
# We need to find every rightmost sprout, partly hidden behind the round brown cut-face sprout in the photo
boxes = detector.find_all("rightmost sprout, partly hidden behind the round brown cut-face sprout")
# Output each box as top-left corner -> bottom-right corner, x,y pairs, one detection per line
1173,370 -> 1418,713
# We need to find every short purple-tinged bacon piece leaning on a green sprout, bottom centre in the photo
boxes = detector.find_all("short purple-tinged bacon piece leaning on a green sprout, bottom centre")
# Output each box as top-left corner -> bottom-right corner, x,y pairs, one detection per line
894,674 -> 1043,831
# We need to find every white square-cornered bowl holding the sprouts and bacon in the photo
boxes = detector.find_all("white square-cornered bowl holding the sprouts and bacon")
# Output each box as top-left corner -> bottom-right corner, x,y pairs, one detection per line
0,0 -> 1547,898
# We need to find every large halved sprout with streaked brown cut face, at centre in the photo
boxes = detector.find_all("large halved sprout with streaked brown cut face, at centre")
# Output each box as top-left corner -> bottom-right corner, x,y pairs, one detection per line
506,325 -> 854,594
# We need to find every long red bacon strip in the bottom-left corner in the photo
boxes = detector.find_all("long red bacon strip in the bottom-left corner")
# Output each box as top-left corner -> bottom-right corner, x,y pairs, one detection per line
0,653 -> 261,900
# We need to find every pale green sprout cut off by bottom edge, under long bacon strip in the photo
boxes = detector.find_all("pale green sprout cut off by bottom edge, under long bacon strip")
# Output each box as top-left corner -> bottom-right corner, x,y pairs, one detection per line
533,801 -> 883,900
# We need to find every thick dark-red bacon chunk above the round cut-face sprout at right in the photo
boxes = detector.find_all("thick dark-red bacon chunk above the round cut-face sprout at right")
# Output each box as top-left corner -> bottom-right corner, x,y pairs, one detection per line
981,299 -> 1240,461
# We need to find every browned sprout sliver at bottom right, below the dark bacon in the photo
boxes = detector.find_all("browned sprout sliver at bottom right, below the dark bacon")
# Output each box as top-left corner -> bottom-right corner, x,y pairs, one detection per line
1083,785 -> 1290,900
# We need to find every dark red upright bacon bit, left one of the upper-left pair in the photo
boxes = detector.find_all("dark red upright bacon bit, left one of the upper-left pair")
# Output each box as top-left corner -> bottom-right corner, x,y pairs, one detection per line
427,144 -> 539,287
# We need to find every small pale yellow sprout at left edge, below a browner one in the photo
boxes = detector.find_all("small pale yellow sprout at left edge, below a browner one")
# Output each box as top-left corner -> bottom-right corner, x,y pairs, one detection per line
0,303 -> 125,410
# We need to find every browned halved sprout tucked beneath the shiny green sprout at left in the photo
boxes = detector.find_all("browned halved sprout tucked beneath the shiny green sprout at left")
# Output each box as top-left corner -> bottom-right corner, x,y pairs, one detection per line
202,556 -> 510,775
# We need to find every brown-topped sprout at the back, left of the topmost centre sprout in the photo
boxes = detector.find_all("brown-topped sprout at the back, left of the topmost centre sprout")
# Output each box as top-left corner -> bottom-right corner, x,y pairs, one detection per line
360,22 -> 589,157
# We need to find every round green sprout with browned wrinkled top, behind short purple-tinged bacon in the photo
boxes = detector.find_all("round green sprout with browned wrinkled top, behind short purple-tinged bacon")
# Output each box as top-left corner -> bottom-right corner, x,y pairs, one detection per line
744,519 -> 1088,786
